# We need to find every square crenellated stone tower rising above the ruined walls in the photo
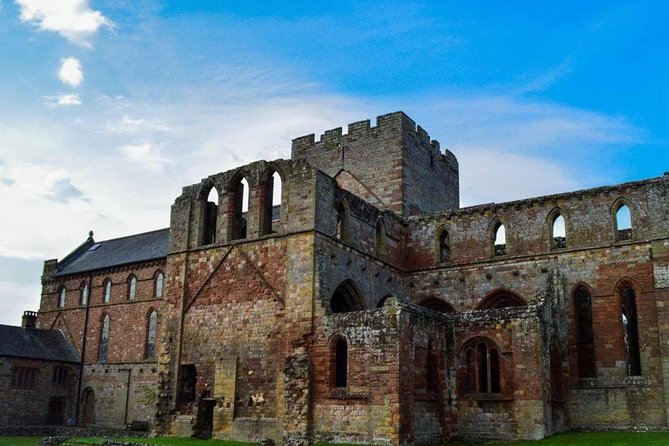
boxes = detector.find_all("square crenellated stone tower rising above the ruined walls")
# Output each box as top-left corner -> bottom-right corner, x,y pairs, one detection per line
292,112 -> 460,216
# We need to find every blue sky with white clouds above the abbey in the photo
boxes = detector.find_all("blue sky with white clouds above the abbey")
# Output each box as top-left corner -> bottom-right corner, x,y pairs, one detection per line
0,0 -> 669,324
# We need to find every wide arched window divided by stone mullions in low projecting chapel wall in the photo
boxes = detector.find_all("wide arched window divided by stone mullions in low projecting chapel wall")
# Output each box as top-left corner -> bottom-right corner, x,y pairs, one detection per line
463,340 -> 501,394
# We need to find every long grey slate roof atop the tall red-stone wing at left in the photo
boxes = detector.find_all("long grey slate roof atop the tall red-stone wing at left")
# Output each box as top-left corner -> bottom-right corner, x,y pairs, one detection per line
56,228 -> 170,276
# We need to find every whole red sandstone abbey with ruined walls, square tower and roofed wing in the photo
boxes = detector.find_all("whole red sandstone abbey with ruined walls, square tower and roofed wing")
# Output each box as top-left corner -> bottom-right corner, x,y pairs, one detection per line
0,112 -> 669,445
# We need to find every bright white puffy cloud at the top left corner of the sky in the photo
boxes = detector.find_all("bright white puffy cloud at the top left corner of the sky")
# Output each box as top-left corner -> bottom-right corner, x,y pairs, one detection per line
16,0 -> 113,48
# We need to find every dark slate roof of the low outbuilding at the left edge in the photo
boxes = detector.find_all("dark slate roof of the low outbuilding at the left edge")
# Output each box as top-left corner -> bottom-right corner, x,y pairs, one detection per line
0,325 -> 79,362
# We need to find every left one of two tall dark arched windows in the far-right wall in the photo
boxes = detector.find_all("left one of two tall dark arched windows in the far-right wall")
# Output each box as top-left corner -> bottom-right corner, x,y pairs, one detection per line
574,286 -> 597,378
